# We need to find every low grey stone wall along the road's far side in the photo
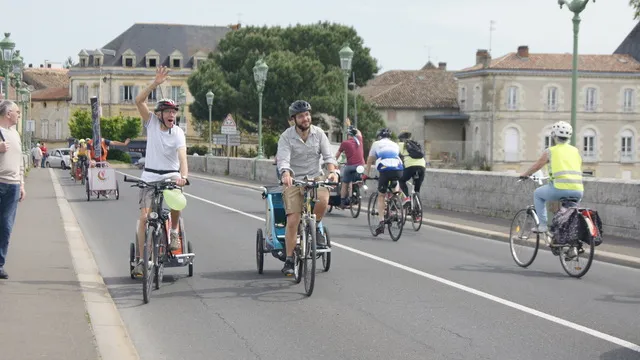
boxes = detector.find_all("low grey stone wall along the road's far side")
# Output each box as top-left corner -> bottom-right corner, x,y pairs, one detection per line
189,156 -> 640,239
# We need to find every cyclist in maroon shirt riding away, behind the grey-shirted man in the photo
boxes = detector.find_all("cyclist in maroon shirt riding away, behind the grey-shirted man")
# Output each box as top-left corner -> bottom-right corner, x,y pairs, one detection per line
336,126 -> 364,208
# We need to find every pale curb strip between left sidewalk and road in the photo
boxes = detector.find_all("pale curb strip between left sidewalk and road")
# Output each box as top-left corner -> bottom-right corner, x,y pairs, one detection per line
49,168 -> 140,360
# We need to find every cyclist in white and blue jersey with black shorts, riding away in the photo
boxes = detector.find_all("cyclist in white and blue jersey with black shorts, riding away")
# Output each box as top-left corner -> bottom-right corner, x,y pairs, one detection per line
363,128 -> 404,234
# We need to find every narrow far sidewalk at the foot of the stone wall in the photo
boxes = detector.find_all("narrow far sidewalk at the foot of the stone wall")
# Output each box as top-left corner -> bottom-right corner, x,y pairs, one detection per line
190,172 -> 640,268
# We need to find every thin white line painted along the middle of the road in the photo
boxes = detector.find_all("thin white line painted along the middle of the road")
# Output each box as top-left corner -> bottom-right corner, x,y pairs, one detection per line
118,171 -> 640,353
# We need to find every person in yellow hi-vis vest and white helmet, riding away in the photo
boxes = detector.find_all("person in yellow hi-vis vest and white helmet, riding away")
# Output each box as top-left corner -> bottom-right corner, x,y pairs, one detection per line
520,121 -> 584,233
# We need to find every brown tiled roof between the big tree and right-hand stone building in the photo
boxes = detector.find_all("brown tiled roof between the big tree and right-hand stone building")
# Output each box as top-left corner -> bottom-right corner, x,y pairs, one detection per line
359,69 -> 458,109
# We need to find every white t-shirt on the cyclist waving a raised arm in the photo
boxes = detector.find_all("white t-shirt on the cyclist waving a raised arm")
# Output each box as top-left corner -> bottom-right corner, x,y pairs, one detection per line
140,113 -> 187,182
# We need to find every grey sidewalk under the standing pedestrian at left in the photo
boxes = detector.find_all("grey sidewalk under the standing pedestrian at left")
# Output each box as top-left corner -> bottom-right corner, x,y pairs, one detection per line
0,168 -> 99,360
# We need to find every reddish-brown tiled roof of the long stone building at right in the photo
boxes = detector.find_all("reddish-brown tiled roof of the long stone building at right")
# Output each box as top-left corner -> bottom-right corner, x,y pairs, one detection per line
460,52 -> 640,73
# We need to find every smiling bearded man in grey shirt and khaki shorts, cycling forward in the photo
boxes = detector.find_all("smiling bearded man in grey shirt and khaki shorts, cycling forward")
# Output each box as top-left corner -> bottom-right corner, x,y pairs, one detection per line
276,100 -> 338,276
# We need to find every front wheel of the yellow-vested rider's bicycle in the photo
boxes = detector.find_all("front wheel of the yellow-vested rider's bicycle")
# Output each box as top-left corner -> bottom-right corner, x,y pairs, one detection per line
509,209 -> 540,268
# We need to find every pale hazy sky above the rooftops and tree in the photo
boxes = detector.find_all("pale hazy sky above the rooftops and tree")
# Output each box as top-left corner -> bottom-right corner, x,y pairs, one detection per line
0,0 -> 636,72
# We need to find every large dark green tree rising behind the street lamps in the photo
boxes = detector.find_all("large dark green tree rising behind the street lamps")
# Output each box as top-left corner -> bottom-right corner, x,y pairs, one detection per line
188,22 -> 378,138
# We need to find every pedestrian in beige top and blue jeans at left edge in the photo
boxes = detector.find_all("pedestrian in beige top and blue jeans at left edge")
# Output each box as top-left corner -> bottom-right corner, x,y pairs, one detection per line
0,100 -> 25,279
